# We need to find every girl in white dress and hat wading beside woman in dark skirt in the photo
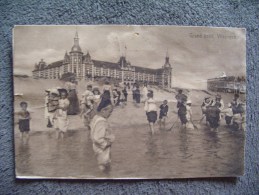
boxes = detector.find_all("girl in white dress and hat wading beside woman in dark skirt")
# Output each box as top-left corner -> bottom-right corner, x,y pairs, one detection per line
54,89 -> 69,139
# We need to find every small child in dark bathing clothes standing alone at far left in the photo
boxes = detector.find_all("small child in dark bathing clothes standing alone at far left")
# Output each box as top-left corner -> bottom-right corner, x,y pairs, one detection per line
18,102 -> 31,142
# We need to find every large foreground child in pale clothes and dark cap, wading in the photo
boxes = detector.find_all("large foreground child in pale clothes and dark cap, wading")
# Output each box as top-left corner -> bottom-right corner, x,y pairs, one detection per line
90,98 -> 115,172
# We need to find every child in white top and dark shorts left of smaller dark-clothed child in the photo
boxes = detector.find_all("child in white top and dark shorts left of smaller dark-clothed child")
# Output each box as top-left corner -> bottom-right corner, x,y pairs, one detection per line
144,90 -> 157,135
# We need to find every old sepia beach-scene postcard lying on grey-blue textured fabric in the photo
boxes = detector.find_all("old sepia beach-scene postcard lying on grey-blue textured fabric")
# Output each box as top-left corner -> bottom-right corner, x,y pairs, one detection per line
13,25 -> 246,179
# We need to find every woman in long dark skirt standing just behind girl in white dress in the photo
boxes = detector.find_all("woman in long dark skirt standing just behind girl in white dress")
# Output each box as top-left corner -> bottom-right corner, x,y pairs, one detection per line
65,78 -> 79,115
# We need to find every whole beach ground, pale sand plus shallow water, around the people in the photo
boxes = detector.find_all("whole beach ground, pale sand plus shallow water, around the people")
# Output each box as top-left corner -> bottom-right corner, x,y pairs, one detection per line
14,78 -> 245,179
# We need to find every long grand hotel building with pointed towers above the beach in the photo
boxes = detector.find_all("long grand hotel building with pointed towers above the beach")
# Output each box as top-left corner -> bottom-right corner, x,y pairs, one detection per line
32,33 -> 172,88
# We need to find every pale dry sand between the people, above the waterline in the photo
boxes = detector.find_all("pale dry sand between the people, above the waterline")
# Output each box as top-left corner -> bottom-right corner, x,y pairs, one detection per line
14,78 -> 244,133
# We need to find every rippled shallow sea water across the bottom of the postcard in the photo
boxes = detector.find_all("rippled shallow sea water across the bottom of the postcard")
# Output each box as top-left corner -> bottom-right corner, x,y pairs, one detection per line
15,122 -> 244,178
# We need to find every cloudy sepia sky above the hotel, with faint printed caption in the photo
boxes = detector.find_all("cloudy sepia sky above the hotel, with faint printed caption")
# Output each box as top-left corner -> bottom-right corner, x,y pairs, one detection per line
13,25 -> 246,89
